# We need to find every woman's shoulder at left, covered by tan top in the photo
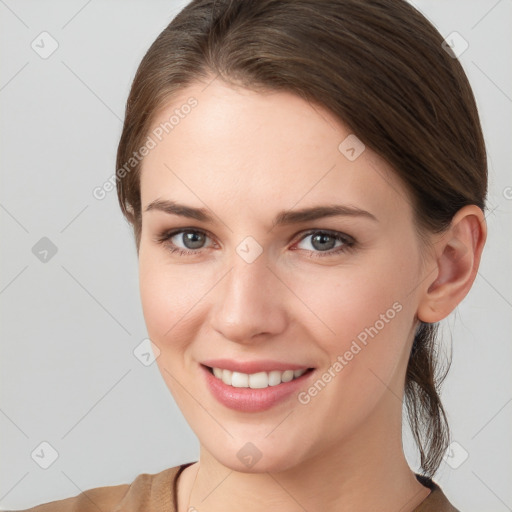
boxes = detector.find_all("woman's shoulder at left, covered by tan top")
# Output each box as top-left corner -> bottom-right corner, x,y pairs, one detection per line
7,466 -> 182,512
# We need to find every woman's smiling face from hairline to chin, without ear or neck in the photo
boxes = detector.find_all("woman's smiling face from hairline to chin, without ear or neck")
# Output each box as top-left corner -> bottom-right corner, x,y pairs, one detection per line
139,80 -> 429,472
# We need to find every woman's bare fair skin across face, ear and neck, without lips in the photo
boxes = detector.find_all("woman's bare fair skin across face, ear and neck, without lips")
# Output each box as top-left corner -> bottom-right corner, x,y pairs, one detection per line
139,79 -> 486,512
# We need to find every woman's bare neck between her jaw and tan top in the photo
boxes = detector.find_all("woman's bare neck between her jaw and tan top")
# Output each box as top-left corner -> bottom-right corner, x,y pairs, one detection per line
178,393 -> 430,512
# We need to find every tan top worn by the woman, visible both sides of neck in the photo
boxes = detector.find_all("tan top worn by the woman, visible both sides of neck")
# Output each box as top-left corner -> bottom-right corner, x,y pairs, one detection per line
7,462 -> 459,512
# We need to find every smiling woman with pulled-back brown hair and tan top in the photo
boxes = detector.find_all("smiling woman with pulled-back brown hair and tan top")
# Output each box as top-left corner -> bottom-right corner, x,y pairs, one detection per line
13,0 -> 487,512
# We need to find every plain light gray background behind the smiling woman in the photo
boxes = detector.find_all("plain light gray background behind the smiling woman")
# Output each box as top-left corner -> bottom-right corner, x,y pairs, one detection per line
0,0 -> 512,512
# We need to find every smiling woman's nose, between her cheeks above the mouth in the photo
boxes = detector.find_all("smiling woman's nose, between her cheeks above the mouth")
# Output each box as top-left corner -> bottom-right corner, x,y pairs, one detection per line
211,254 -> 290,344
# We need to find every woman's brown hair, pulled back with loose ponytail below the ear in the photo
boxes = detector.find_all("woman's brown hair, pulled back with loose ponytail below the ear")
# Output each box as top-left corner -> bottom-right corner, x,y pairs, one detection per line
116,0 -> 487,476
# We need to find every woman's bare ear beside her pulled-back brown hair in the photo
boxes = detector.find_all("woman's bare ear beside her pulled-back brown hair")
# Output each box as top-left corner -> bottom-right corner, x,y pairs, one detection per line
418,205 -> 487,323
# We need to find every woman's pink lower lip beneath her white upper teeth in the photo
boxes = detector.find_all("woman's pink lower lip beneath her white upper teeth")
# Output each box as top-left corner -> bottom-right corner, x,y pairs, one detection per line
201,365 -> 314,412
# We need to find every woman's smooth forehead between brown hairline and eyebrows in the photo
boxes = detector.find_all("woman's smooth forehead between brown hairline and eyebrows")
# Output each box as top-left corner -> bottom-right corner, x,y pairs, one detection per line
141,79 -> 408,222
